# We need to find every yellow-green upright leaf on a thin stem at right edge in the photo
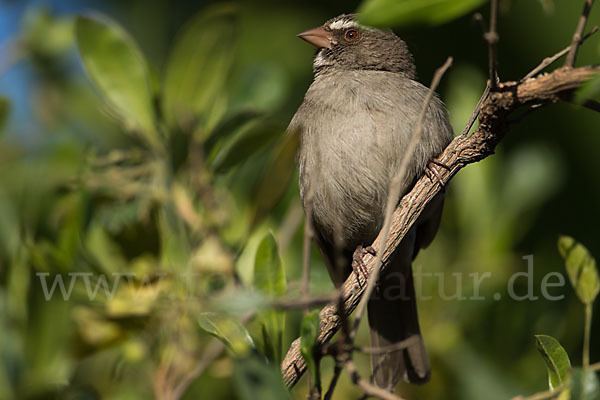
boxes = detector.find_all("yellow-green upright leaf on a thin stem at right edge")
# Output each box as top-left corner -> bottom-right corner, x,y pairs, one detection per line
558,236 -> 600,304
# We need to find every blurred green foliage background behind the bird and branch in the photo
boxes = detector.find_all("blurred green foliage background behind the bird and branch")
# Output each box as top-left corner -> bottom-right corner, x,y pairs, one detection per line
0,0 -> 600,399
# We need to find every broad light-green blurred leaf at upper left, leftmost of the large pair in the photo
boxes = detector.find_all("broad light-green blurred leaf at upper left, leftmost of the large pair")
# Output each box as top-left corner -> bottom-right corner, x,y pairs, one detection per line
75,16 -> 159,148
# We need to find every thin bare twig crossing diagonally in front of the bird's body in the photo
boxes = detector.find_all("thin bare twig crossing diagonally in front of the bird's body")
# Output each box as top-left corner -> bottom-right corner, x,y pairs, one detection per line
351,57 -> 452,337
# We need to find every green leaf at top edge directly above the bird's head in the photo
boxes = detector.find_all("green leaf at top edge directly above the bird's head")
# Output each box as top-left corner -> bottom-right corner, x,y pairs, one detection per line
358,0 -> 485,26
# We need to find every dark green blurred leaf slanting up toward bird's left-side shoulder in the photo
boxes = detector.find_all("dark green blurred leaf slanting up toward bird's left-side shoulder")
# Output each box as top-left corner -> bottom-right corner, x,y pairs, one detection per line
211,116 -> 283,173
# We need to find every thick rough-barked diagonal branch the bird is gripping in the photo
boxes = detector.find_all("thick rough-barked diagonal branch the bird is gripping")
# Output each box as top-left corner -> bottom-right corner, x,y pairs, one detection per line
281,66 -> 600,387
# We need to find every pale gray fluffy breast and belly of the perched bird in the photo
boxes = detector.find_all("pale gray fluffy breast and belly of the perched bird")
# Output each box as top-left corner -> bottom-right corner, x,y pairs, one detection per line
299,84 -> 395,247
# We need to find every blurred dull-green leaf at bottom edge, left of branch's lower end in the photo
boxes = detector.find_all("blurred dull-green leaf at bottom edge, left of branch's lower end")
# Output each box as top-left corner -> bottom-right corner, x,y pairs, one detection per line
234,355 -> 290,400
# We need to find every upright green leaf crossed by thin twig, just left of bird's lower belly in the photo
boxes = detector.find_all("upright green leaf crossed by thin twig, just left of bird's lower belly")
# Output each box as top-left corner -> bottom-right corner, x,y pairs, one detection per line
254,232 -> 287,363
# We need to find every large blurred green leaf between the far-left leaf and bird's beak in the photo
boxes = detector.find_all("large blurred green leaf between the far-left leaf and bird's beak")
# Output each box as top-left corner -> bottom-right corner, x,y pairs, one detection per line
164,4 -> 239,128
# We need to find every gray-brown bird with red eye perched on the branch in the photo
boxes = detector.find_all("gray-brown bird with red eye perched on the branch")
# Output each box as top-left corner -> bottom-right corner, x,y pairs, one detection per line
288,15 -> 452,390
